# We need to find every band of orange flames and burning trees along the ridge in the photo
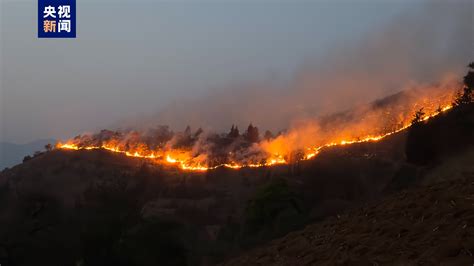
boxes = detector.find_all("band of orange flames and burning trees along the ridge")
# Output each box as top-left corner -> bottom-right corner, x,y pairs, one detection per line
56,72 -> 471,171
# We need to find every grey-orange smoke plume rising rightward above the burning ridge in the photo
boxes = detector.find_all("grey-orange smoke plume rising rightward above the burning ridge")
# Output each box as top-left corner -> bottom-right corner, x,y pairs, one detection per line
121,0 -> 474,135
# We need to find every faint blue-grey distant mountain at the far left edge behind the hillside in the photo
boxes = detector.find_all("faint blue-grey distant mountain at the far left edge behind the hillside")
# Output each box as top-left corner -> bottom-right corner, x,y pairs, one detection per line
0,139 -> 56,170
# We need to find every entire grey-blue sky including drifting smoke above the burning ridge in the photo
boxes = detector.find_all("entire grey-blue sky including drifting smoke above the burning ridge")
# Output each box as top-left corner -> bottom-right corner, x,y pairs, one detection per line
0,0 -> 474,142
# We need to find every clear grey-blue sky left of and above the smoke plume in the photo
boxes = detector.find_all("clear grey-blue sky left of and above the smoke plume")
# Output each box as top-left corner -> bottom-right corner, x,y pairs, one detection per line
0,0 -> 472,142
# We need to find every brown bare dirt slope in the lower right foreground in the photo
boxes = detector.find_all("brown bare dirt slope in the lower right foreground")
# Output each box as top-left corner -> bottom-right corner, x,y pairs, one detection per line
225,172 -> 474,265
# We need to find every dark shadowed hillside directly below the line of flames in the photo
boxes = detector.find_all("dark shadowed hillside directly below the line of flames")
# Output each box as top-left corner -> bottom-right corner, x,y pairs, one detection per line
0,103 -> 474,265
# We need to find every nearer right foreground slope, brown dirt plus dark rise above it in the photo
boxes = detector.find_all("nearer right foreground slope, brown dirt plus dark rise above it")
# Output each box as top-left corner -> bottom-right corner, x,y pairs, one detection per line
225,104 -> 474,265
